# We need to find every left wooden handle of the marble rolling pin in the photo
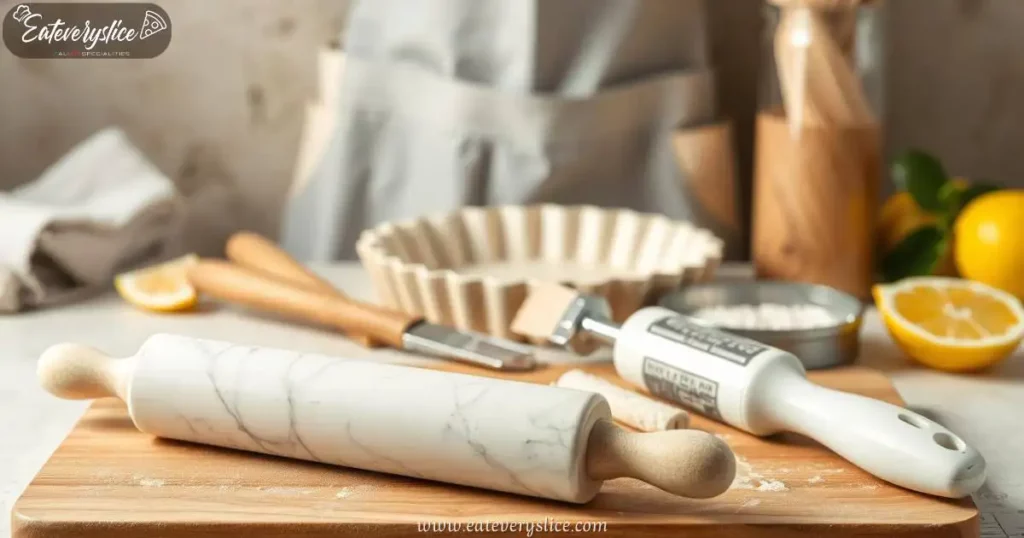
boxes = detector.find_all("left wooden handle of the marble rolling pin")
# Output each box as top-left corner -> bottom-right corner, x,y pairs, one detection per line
36,343 -> 135,401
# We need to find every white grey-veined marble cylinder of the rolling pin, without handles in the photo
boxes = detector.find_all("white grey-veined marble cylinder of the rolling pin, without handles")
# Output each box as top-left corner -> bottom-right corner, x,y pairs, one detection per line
128,334 -> 610,502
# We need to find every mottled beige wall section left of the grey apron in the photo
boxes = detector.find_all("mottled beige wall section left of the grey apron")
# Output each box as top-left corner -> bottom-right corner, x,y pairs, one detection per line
0,0 -> 346,252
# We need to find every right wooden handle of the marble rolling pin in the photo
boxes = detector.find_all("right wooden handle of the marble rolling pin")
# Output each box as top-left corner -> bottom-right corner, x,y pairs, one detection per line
587,420 -> 736,499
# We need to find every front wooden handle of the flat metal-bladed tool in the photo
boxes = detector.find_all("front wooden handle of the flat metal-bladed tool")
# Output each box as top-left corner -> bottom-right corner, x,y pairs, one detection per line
187,260 -> 420,349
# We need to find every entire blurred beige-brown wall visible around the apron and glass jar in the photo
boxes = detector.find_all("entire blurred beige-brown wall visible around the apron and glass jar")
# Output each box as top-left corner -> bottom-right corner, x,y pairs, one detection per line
0,0 -> 1024,256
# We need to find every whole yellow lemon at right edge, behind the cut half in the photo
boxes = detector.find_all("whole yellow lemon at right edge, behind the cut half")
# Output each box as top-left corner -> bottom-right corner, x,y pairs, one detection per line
954,191 -> 1024,299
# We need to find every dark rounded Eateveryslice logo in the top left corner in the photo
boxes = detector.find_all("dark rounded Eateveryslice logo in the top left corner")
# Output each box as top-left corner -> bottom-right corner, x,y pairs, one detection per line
3,3 -> 171,59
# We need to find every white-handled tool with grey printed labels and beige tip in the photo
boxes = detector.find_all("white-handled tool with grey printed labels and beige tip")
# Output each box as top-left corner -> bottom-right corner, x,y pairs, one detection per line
512,285 -> 985,498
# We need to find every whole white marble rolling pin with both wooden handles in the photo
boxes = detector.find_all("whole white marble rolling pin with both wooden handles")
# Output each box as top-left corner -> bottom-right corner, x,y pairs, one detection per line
38,334 -> 735,503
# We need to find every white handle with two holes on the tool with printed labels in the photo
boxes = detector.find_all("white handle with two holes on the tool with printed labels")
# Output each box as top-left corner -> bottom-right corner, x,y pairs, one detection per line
753,369 -> 985,498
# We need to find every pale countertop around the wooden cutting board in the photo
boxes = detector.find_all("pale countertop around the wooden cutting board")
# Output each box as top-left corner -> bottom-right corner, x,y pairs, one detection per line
0,264 -> 1024,538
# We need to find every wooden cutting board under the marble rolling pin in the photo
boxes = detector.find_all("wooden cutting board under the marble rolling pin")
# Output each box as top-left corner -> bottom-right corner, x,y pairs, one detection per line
12,365 -> 979,538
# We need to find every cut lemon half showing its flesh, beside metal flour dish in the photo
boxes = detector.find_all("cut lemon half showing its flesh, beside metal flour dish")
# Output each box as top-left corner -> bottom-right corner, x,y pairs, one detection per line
873,277 -> 1024,372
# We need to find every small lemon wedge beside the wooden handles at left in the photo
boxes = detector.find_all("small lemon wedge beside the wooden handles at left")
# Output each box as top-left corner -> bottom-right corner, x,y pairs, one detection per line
114,254 -> 199,312
